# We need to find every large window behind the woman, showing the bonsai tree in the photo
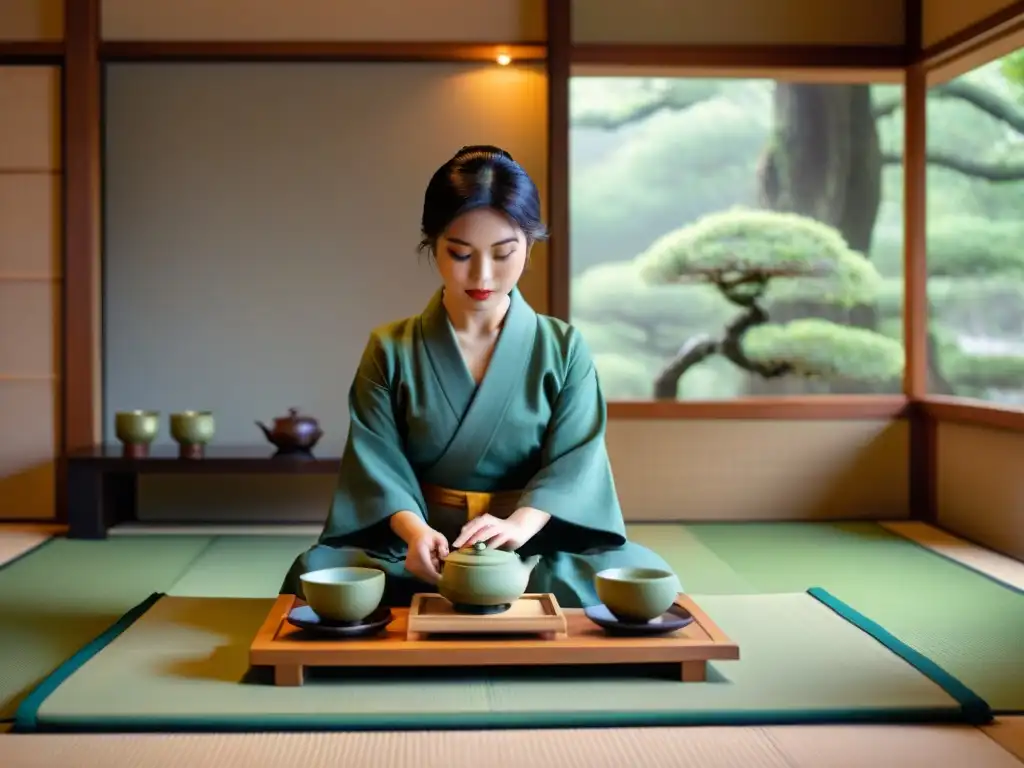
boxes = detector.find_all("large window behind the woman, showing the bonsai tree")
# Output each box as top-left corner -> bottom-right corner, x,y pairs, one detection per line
569,76 -> 905,400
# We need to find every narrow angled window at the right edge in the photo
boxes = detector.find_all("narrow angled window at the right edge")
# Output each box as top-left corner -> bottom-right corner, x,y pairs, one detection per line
927,50 -> 1024,406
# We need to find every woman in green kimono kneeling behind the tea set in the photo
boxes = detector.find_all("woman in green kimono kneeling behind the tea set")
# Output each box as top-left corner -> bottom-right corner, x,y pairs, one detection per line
281,146 -> 669,607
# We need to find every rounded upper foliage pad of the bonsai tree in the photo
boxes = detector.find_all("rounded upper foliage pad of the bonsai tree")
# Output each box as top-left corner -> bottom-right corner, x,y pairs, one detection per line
637,208 -> 882,306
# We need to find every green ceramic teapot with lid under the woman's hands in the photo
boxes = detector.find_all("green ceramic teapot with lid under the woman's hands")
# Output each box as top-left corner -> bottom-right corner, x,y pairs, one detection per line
437,542 -> 541,613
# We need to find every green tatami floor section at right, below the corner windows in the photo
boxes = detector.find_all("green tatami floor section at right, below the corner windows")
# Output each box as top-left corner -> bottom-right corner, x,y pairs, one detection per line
669,521 -> 1024,715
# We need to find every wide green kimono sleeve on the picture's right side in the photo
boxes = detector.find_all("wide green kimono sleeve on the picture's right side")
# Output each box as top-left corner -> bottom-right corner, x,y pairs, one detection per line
519,334 -> 626,553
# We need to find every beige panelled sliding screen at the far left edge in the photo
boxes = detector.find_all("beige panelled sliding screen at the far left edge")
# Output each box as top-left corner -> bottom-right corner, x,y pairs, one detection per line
0,67 -> 61,519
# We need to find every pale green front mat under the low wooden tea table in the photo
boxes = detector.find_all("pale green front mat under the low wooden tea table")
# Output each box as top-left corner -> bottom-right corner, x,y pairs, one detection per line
17,594 -> 979,733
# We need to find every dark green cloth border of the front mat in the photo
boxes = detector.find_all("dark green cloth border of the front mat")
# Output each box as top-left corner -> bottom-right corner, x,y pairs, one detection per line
11,587 -> 993,733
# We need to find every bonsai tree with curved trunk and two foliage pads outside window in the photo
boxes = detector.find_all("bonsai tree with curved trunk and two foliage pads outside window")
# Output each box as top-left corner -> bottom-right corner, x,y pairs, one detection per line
637,209 -> 904,399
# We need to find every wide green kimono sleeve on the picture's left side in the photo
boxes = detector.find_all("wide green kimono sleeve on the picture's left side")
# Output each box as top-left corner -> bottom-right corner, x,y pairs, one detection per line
319,334 -> 426,551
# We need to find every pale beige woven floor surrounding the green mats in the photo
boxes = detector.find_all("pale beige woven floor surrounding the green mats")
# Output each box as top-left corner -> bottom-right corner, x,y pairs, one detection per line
0,522 -> 1024,768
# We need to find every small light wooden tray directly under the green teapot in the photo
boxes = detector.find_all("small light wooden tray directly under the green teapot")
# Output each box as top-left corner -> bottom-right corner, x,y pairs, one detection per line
406,593 -> 568,640
